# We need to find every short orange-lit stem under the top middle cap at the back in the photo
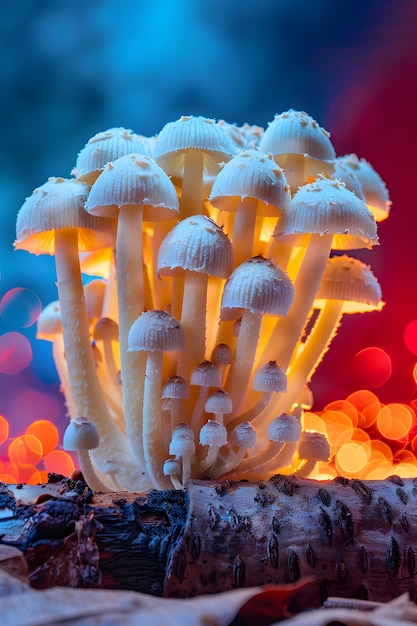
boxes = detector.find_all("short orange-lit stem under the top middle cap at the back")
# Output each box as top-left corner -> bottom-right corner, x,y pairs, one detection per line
180,150 -> 204,219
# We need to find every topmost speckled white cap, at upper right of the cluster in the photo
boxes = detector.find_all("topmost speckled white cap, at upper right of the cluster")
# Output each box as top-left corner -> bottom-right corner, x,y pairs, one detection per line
259,109 -> 336,163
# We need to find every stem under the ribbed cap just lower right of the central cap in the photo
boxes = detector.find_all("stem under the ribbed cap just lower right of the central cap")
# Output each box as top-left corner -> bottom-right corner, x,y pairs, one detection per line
226,309 -> 262,415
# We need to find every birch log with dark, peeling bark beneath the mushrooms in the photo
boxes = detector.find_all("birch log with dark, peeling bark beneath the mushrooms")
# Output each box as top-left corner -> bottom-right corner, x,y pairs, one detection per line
0,475 -> 417,610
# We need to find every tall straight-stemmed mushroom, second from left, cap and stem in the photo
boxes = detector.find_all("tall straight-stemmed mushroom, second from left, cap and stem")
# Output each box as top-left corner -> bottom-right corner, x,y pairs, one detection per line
86,153 -> 178,464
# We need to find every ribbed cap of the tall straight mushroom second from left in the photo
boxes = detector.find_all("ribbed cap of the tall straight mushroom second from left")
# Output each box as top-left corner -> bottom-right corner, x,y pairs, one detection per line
85,153 -> 179,221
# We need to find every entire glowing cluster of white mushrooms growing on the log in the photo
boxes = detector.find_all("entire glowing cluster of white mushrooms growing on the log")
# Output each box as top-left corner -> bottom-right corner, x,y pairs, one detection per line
15,110 -> 390,491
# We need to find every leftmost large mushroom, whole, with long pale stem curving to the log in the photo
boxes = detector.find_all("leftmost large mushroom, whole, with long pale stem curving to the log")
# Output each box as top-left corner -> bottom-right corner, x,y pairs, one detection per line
15,178 -> 142,489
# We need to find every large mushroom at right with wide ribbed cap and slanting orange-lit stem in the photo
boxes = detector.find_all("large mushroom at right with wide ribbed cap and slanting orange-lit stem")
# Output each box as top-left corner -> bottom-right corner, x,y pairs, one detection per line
261,178 -> 378,369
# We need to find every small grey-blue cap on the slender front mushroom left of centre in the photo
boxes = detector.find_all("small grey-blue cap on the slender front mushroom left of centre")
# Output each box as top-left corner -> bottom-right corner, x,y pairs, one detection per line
128,310 -> 185,352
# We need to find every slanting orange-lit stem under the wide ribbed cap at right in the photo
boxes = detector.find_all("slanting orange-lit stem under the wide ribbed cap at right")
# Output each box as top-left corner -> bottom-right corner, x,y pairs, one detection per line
262,233 -> 333,370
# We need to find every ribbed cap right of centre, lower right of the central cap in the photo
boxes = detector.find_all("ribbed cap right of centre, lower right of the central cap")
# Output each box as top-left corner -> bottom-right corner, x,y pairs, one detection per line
221,256 -> 294,319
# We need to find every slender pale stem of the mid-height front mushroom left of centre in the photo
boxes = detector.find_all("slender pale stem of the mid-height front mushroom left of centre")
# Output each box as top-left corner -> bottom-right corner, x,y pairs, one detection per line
143,350 -> 169,489
